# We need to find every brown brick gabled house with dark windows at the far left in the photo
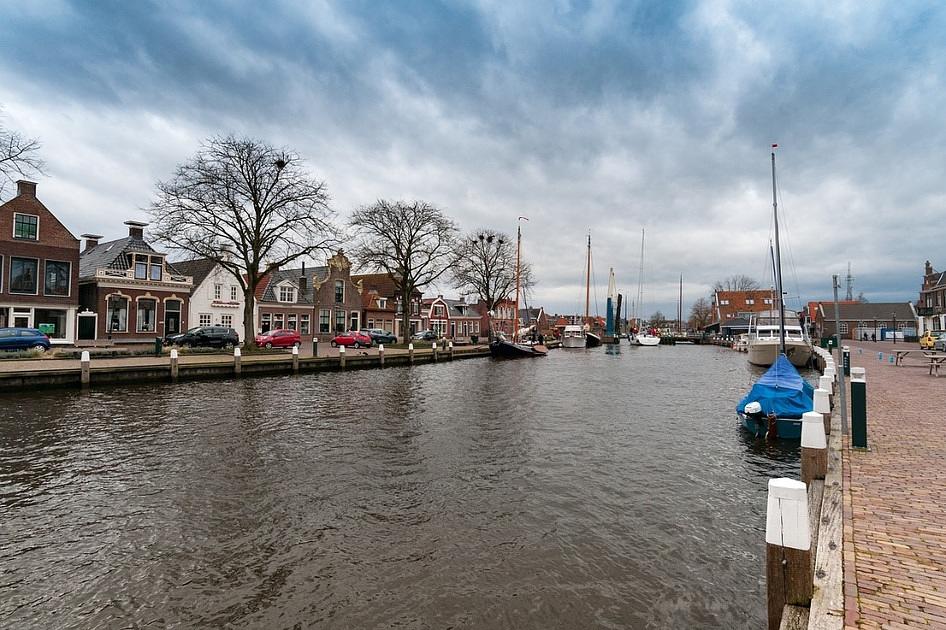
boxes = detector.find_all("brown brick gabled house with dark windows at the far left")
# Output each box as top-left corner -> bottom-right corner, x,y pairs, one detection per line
0,180 -> 79,344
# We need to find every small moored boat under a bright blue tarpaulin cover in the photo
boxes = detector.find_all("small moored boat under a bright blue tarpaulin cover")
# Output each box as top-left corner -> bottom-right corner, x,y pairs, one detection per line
736,354 -> 815,440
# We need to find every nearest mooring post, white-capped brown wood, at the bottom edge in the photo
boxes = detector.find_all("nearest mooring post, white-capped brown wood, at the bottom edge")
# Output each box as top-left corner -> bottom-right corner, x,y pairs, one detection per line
765,478 -> 813,630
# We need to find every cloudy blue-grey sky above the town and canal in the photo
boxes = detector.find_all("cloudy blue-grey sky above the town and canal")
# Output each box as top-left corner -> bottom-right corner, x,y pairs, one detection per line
0,0 -> 946,316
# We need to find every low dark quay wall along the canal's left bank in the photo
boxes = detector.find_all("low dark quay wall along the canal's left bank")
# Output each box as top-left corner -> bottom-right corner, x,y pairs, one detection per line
0,348 -> 490,394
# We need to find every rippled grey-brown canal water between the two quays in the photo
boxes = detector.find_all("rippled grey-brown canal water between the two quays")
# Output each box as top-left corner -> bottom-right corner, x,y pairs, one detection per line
0,345 -> 799,629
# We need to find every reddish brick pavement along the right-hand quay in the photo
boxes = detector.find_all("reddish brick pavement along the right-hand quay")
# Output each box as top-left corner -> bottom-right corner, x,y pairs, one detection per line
844,342 -> 946,630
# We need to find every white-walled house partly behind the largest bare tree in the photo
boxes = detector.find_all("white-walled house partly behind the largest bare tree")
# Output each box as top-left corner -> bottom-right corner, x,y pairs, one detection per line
174,258 -> 244,341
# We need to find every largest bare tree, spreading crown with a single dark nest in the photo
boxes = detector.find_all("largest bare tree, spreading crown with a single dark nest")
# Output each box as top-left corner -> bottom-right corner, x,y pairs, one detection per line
150,136 -> 338,344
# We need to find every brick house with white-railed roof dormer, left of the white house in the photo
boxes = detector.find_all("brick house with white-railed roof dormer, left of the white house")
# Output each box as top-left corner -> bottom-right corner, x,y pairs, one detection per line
77,221 -> 193,343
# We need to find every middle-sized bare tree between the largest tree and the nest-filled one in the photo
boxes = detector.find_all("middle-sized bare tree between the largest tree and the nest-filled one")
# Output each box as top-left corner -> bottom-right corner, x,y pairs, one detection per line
350,199 -> 457,335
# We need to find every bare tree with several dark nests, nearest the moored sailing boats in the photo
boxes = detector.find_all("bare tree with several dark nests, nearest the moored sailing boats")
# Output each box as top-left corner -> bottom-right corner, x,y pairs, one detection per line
450,229 -> 533,311
